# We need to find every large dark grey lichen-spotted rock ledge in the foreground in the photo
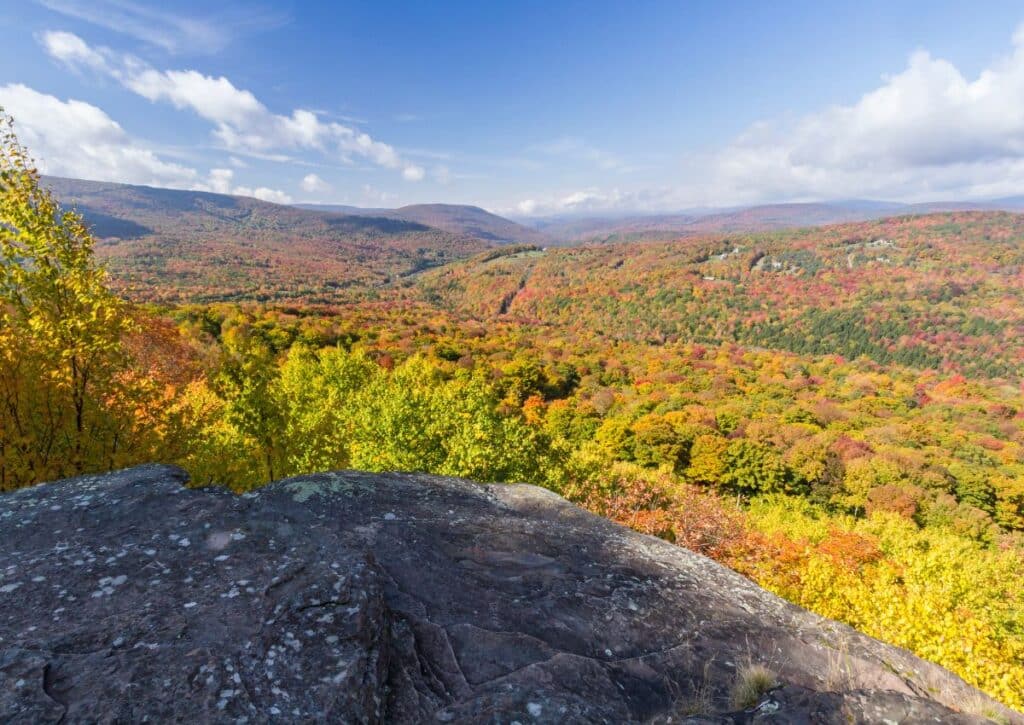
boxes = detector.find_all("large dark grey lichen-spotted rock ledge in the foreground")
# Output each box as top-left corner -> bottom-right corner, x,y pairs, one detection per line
0,466 -> 1021,724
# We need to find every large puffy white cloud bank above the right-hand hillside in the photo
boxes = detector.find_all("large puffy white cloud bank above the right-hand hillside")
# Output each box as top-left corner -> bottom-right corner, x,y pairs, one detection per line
710,24 -> 1024,201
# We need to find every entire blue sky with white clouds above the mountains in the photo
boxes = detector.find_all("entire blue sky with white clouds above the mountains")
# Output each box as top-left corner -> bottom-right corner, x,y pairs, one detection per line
0,0 -> 1024,216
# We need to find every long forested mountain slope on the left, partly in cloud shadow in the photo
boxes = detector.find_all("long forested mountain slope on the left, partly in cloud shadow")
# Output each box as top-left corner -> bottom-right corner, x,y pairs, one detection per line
45,177 -> 495,303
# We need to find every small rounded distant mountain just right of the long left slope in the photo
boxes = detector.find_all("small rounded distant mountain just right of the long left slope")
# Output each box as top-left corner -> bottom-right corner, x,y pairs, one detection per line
295,204 -> 551,244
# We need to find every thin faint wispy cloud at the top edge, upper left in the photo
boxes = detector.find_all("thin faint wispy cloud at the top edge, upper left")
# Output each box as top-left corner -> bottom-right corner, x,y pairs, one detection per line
37,0 -> 285,53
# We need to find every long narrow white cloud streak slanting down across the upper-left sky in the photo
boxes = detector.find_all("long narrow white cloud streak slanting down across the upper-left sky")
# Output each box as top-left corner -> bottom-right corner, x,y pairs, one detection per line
40,31 -> 424,181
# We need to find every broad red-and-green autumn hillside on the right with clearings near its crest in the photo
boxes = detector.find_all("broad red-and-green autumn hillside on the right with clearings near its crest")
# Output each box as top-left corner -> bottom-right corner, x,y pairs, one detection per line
421,212 -> 1024,380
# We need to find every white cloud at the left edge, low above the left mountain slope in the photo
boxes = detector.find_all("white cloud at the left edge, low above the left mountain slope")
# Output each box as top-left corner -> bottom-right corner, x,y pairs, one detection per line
0,84 -> 199,187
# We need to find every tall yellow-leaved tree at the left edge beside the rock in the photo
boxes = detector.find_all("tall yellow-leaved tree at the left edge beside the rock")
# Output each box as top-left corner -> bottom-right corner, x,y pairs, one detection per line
0,109 -> 144,489
